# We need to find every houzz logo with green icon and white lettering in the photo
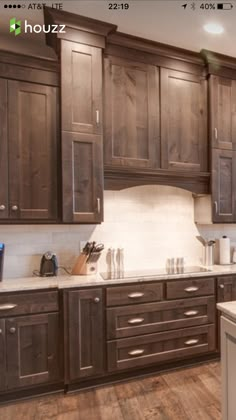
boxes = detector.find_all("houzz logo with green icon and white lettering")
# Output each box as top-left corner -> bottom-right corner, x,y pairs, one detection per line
10,18 -> 66,35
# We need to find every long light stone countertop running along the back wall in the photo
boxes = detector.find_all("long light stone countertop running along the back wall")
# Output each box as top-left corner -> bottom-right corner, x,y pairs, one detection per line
0,264 -> 236,293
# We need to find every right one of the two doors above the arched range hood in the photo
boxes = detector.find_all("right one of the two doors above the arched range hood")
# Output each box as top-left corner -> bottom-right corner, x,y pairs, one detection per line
161,69 -> 208,172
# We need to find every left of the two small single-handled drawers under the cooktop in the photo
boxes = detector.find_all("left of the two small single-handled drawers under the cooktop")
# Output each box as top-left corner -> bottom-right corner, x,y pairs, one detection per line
106,283 -> 163,306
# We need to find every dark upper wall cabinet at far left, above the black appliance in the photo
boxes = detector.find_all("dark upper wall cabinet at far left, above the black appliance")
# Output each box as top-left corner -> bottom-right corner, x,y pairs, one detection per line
0,54 -> 58,222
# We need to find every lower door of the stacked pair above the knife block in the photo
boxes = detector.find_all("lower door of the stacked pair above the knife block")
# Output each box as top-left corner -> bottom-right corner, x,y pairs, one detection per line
62,132 -> 103,223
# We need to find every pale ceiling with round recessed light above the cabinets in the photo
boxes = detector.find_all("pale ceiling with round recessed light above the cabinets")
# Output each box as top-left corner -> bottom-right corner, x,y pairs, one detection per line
0,0 -> 236,57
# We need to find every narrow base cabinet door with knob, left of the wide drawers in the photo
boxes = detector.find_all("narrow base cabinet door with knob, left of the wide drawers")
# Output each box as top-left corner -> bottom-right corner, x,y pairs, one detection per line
64,289 -> 105,383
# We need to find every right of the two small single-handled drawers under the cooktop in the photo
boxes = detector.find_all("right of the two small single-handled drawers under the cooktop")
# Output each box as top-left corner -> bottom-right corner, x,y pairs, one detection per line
166,278 -> 215,299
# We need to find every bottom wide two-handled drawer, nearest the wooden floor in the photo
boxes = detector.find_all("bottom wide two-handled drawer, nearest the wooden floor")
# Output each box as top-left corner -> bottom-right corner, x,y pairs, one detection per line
107,325 -> 215,372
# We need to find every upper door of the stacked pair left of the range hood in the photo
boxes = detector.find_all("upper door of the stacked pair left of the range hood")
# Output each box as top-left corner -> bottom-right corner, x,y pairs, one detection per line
61,41 -> 102,134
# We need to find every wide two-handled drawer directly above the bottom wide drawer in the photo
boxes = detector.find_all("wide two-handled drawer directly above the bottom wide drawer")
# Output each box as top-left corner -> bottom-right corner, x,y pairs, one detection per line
107,297 -> 216,340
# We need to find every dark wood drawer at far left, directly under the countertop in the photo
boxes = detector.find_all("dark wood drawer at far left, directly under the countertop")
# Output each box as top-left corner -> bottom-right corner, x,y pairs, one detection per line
0,291 -> 58,317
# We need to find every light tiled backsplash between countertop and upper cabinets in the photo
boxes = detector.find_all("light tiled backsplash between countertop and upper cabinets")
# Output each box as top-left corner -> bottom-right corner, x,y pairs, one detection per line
0,186 -> 221,278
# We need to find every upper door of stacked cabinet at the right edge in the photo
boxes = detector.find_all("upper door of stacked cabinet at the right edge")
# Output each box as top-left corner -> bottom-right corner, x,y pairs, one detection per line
210,76 -> 236,150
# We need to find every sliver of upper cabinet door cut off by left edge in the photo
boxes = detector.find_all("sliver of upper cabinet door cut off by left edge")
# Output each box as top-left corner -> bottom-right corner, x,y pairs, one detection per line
0,79 -> 8,219
